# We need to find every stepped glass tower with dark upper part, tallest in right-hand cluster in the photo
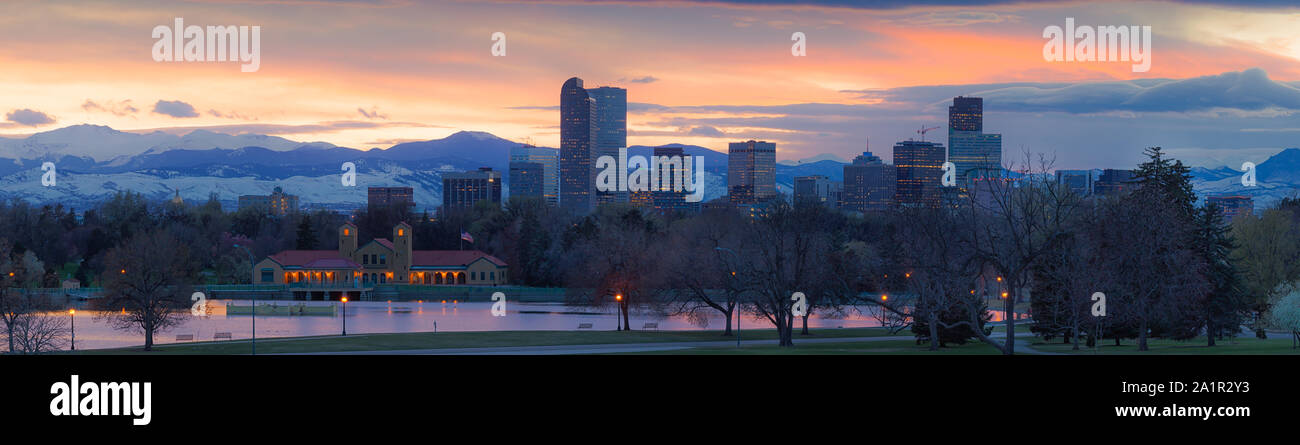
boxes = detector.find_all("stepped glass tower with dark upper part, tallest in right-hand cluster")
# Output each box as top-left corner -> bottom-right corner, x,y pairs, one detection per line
948,96 -> 1002,185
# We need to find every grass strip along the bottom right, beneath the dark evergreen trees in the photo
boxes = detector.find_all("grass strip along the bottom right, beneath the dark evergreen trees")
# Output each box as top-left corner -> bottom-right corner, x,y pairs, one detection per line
1030,337 -> 1300,355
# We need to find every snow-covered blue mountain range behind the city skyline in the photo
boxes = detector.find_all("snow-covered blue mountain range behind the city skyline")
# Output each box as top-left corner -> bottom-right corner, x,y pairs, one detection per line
0,125 -> 1300,209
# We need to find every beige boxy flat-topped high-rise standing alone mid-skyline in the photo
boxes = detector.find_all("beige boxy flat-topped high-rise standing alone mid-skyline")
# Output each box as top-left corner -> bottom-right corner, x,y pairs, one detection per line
727,141 -> 776,204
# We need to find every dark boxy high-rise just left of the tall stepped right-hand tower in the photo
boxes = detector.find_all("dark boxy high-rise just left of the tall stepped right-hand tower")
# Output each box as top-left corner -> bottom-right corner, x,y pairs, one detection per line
894,141 -> 944,207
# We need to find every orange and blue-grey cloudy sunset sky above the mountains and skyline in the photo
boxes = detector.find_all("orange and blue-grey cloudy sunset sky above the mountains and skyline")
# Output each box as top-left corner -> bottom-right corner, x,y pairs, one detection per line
0,0 -> 1300,168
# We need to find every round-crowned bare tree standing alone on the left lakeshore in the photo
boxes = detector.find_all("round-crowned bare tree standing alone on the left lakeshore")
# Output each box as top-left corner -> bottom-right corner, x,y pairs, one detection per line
99,230 -> 196,351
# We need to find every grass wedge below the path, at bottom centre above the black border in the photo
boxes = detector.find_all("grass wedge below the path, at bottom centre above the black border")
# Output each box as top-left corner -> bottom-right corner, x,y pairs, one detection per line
624,336 -> 1001,355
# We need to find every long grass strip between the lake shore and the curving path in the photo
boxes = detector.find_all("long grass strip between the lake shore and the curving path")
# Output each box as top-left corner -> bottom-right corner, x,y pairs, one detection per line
75,328 -> 909,355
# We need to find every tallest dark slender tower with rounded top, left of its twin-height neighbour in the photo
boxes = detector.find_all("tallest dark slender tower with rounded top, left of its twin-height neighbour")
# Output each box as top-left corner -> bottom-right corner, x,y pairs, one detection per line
560,77 -> 597,213
